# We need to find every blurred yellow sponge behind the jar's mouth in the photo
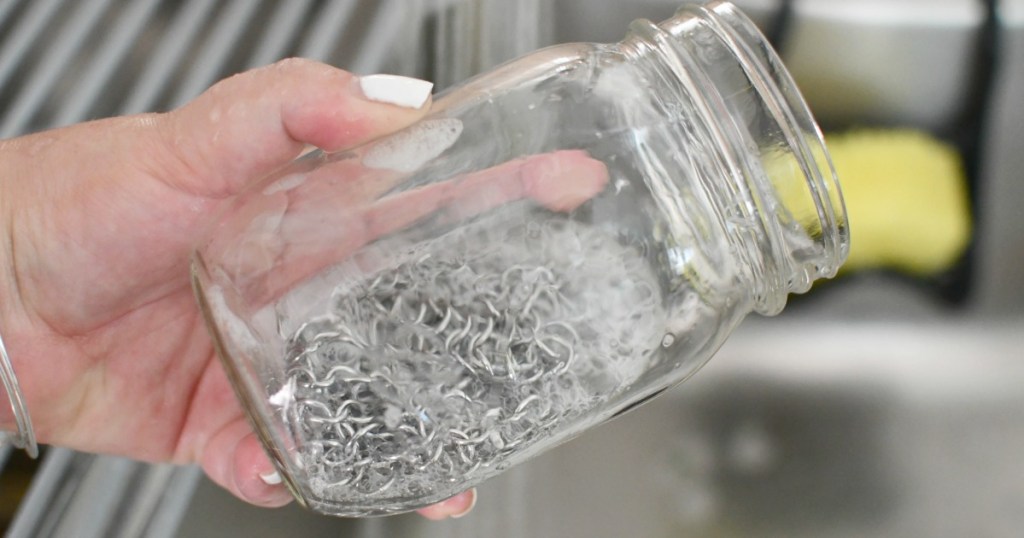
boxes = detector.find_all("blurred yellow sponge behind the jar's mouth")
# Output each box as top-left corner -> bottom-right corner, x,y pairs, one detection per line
826,129 -> 971,276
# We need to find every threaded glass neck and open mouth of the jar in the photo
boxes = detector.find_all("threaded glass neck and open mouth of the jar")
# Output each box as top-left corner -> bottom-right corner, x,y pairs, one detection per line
631,1 -> 849,315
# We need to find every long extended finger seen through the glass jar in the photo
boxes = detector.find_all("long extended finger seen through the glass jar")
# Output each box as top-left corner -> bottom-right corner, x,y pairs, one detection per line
248,151 -> 608,304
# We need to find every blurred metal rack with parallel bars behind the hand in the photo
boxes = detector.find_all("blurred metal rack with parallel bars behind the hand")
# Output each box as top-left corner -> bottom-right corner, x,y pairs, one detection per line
0,0 -> 545,538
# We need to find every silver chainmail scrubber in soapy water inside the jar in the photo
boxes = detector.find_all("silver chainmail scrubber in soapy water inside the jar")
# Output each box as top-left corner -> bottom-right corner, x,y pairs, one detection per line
276,216 -> 655,498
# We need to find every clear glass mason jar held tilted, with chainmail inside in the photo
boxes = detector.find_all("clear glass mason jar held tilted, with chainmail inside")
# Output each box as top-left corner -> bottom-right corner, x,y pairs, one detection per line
194,2 -> 848,515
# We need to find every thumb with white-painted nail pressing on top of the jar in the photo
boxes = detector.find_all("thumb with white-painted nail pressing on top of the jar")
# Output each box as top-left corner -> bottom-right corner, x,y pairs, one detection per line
165,58 -> 431,197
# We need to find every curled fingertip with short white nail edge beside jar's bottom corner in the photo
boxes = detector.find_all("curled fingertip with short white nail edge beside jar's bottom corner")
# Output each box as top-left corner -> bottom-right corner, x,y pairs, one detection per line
202,418 -> 292,507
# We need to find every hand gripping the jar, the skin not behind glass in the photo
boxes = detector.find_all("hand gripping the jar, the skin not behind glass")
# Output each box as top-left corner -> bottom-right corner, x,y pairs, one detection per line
0,60 -> 474,519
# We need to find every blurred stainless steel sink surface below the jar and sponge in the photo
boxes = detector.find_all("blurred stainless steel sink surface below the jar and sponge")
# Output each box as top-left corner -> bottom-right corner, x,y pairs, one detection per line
167,317 -> 1024,537
